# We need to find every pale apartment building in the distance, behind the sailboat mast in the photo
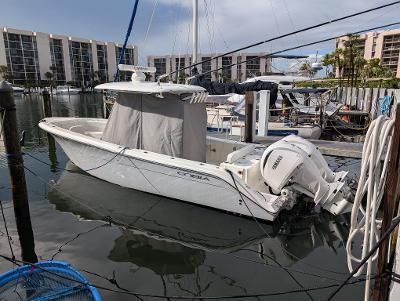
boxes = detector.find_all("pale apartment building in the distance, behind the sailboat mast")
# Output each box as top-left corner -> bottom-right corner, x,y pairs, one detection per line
147,52 -> 271,82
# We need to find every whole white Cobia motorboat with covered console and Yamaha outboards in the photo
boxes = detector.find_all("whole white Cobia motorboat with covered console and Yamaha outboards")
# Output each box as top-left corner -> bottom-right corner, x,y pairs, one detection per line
39,65 -> 351,221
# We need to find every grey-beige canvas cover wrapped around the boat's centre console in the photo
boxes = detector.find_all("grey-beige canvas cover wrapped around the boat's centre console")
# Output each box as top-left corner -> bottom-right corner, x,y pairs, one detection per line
102,92 -> 207,162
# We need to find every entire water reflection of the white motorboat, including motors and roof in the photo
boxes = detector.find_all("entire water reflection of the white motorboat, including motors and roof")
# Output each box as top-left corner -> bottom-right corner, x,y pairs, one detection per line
49,163 -> 348,275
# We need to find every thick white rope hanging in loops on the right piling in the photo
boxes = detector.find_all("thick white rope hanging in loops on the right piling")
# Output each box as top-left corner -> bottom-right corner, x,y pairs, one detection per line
346,116 -> 394,299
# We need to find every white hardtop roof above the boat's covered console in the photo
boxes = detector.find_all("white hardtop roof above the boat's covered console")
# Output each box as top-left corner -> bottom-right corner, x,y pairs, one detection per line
95,81 -> 206,95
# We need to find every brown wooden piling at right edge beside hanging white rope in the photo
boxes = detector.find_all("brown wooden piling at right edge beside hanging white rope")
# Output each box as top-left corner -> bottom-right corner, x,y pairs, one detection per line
373,104 -> 400,301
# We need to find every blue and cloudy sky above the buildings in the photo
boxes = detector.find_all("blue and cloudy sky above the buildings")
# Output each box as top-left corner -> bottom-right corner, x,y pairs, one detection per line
0,0 -> 400,68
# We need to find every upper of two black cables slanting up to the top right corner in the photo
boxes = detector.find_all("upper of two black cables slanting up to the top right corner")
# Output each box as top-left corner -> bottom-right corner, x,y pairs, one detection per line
164,1 -> 400,76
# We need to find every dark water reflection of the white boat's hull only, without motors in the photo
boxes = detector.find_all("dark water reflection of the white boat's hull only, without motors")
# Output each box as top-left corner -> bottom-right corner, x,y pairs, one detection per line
48,162 -> 273,253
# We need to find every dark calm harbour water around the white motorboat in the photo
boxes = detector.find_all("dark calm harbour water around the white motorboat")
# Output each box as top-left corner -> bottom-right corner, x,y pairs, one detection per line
0,95 -> 363,300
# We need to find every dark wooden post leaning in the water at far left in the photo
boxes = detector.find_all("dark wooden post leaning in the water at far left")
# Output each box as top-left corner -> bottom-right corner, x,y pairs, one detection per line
0,81 -> 37,263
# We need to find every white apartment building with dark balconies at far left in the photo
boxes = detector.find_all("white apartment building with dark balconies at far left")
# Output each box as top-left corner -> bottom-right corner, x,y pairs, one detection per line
0,27 -> 138,86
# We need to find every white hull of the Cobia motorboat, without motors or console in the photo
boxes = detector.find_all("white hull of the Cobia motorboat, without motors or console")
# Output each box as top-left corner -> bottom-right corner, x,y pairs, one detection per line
39,118 -> 281,221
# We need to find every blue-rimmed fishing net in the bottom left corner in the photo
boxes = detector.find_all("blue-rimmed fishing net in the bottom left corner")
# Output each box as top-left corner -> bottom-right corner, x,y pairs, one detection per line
0,262 -> 101,301
